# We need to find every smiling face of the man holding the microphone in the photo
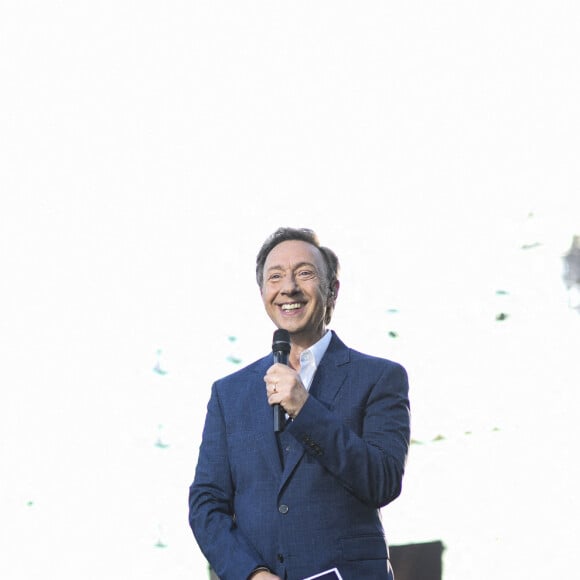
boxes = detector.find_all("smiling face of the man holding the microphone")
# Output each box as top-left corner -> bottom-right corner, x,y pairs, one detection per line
261,240 -> 328,346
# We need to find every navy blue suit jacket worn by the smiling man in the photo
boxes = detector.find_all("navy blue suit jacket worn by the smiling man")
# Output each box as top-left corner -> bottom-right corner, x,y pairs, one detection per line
189,333 -> 409,580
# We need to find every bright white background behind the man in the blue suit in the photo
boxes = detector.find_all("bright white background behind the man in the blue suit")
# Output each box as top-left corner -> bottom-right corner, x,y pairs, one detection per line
0,0 -> 580,580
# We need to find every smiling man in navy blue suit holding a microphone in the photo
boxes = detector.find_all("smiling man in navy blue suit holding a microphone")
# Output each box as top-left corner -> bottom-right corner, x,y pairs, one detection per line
189,228 -> 409,580
